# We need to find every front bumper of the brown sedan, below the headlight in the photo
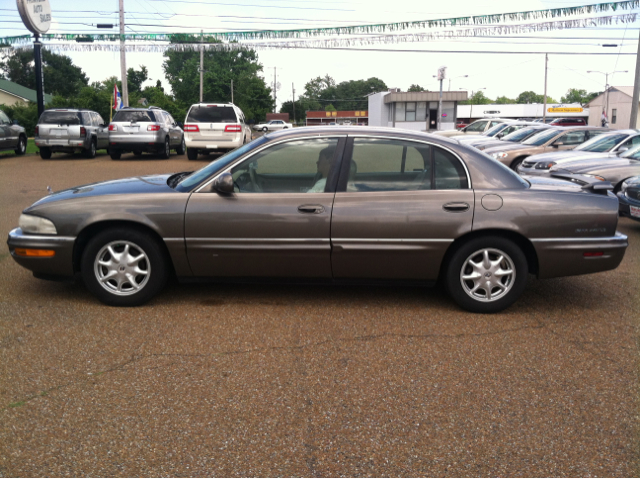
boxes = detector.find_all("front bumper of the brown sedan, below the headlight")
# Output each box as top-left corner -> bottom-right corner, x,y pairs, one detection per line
7,228 -> 76,277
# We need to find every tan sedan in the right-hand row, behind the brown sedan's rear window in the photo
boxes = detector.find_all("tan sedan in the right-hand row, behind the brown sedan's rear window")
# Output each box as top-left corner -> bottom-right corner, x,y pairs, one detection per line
484,126 -> 609,171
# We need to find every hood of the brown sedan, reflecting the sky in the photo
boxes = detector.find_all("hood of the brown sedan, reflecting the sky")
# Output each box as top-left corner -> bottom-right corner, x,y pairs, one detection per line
31,175 -> 177,207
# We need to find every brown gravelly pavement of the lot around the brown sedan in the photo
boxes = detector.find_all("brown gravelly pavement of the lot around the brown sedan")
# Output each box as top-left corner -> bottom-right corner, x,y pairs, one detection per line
0,150 -> 640,477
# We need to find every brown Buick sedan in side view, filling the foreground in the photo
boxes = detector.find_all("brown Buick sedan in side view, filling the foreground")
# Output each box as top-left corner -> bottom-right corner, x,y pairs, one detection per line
8,127 -> 627,313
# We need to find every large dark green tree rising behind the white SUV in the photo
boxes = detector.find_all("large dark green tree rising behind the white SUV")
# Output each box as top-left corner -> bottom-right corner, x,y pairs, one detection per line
162,36 -> 274,121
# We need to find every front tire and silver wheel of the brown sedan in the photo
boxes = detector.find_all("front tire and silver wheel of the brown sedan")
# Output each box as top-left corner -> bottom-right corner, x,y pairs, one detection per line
81,228 -> 169,306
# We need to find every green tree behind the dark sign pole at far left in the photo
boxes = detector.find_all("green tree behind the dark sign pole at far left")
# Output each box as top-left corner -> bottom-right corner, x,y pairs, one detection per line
0,49 -> 89,97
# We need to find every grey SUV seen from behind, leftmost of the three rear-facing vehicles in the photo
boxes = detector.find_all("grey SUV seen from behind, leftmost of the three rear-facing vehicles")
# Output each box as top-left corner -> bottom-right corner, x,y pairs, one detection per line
35,108 -> 109,160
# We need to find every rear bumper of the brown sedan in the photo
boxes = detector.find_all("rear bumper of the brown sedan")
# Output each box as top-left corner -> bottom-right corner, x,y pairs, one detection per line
531,232 -> 629,279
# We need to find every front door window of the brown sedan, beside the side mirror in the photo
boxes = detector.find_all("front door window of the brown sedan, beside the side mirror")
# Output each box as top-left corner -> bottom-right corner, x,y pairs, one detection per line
231,138 -> 338,193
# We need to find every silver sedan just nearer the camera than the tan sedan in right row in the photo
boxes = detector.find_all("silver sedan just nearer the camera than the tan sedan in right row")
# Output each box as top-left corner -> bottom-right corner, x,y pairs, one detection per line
516,130 -> 640,175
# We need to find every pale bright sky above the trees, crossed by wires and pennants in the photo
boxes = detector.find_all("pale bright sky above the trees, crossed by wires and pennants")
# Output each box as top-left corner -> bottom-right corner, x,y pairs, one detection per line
0,0 -> 640,109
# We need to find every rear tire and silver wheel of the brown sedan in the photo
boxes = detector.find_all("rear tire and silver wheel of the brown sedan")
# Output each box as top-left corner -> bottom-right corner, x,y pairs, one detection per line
445,236 -> 528,313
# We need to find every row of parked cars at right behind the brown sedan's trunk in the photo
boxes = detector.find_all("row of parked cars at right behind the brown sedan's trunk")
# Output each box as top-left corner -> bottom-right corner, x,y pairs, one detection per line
436,120 -> 640,221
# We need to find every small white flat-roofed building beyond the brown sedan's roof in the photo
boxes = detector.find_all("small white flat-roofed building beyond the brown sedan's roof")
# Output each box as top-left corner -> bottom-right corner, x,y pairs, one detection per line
369,88 -> 467,131
